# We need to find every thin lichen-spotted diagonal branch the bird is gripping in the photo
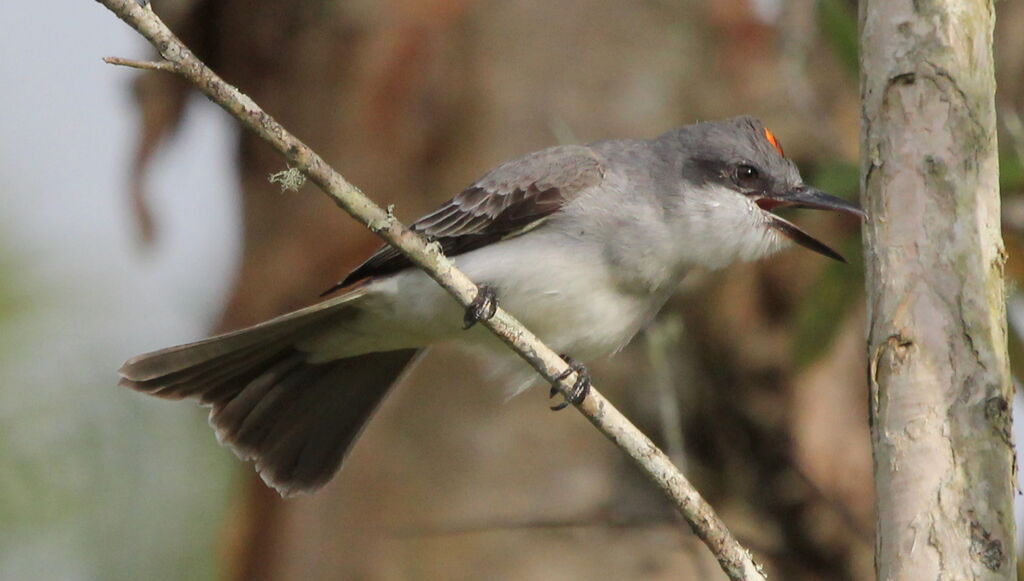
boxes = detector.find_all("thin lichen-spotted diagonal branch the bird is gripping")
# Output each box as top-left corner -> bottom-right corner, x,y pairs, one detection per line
97,0 -> 766,581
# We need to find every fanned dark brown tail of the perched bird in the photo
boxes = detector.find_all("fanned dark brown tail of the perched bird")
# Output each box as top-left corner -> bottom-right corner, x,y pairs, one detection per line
120,289 -> 418,496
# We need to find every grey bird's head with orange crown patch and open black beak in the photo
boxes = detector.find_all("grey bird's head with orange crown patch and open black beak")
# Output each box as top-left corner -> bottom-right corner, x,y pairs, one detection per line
657,117 -> 864,267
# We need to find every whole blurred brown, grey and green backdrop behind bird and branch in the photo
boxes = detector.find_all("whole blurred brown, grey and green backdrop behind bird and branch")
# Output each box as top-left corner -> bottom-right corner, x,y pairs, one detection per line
0,0 -> 1024,581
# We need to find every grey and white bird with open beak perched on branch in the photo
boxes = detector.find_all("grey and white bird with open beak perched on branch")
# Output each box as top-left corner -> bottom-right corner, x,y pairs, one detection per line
120,116 -> 865,496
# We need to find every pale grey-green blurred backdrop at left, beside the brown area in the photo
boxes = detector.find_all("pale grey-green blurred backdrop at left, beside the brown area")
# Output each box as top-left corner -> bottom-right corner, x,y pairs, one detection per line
0,0 -> 239,581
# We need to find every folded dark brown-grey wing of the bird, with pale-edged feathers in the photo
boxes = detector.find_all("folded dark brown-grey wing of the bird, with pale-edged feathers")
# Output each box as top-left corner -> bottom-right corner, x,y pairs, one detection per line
324,146 -> 604,294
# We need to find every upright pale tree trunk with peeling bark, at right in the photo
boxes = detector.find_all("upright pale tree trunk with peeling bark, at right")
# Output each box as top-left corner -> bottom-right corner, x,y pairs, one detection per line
860,0 -> 1016,581
